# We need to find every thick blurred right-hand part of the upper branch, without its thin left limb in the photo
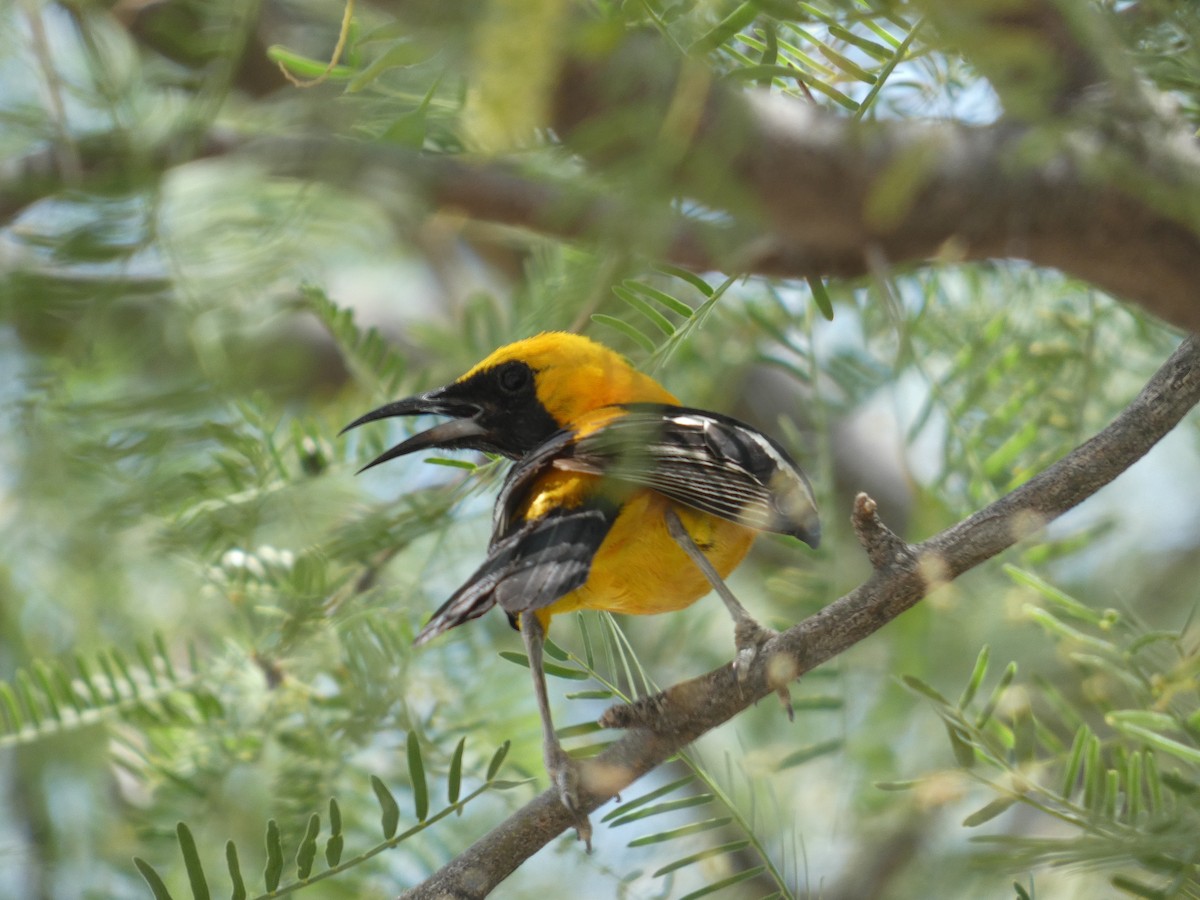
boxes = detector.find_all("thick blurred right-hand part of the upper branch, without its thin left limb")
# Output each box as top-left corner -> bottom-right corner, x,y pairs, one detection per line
554,40 -> 1200,331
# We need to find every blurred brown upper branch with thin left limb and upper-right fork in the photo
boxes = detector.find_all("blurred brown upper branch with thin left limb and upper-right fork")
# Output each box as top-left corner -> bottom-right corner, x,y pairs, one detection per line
0,8 -> 1200,331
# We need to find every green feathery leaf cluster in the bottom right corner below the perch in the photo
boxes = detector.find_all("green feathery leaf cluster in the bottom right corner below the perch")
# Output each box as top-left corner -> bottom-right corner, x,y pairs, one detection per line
905,566 -> 1200,898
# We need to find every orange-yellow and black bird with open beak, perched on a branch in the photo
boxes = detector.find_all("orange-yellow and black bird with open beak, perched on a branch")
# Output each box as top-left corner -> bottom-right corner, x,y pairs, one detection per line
346,332 -> 820,840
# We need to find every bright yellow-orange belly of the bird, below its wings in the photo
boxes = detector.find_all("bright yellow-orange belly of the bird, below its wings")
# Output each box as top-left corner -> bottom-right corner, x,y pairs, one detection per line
538,489 -> 756,625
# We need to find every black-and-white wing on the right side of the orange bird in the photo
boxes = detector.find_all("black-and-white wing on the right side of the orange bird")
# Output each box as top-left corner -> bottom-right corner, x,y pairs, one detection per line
553,403 -> 821,547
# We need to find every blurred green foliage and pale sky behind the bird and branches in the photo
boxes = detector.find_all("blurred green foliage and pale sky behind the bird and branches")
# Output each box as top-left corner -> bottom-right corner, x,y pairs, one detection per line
0,0 -> 1200,899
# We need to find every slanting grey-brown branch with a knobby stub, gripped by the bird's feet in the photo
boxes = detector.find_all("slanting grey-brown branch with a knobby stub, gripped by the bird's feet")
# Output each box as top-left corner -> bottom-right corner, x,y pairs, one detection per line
403,336 -> 1200,900
